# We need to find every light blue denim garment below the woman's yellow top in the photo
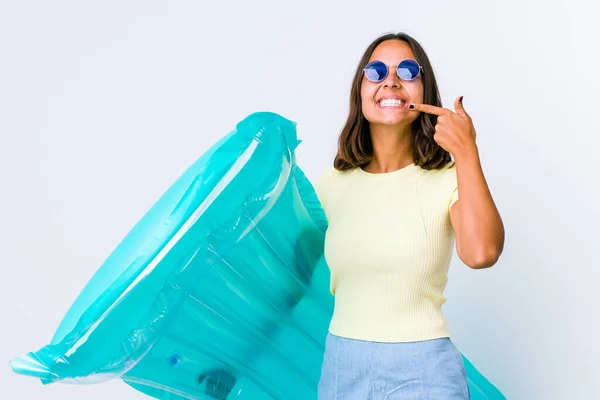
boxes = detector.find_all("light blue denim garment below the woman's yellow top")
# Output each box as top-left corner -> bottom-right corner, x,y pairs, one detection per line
318,333 -> 470,400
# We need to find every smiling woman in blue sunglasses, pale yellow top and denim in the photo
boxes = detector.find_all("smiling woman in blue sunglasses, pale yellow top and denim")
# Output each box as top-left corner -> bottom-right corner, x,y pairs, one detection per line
315,33 -> 504,400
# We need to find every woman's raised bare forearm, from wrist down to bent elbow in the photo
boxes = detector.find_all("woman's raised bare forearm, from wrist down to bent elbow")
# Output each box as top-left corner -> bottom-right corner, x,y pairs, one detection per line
453,146 -> 504,268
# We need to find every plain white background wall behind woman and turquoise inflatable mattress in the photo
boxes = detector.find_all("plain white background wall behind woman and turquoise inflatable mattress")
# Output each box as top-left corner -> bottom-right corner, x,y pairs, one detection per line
0,0 -> 600,400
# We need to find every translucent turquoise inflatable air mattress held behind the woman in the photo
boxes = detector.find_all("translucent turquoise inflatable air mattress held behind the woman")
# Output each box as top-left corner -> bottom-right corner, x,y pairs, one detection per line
11,112 -> 503,400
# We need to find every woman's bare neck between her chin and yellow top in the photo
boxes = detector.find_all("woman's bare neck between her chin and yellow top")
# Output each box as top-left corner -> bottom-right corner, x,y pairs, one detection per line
364,125 -> 414,173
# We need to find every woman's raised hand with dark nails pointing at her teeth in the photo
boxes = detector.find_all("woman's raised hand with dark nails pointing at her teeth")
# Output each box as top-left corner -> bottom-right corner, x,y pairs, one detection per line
409,96 -> 477,158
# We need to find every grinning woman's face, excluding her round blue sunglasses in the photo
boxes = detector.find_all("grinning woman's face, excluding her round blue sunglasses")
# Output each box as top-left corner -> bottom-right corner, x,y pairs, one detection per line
360,40 -> 423,125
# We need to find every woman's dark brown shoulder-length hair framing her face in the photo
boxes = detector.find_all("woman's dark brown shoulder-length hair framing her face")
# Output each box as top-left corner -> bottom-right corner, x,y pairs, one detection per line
333,32 -> 452,171
